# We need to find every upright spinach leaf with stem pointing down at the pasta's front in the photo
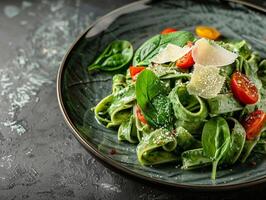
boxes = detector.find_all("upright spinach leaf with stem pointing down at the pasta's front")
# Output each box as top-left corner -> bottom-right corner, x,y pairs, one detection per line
201,117 -> 230,179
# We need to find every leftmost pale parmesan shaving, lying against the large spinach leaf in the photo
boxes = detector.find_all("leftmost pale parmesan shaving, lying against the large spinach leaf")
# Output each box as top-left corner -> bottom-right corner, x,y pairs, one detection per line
151,44 -> 191,64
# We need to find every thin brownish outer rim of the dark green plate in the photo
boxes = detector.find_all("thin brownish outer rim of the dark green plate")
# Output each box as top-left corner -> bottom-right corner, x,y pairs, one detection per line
56,0 -> 266,191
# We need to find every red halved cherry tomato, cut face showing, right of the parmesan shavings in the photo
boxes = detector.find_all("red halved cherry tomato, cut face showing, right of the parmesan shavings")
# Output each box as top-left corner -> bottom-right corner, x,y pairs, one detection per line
231,72 -> 259,104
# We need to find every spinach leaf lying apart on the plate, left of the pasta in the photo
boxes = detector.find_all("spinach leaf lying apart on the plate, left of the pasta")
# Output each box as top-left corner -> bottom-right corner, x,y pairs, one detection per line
88,40 -> 133,71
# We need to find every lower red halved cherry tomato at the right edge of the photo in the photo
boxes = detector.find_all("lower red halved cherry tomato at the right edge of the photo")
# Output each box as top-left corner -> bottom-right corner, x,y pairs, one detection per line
242,110 -> 266,140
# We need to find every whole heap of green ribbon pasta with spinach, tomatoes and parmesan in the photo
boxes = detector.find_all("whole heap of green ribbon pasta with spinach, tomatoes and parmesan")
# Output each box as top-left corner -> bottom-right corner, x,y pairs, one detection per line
89,31 -> 266,179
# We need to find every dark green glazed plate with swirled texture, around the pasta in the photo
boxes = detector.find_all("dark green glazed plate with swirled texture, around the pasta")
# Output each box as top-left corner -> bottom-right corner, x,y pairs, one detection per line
57,0 -> 266,189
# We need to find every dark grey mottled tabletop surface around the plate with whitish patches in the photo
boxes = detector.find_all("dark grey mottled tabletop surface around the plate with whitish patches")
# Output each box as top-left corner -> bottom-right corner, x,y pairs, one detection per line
0,0 -> 266,200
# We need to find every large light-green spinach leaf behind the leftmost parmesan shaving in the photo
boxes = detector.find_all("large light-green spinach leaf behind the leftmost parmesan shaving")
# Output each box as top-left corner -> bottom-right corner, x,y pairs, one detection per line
133,31 -> 195,66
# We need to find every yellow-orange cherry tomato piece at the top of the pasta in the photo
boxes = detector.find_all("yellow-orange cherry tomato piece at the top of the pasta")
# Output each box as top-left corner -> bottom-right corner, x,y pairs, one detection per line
195,26 -> 221,40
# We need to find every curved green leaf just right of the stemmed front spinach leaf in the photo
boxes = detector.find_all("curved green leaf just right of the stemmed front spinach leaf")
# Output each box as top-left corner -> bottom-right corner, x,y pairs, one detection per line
223,118 -> 246,164
